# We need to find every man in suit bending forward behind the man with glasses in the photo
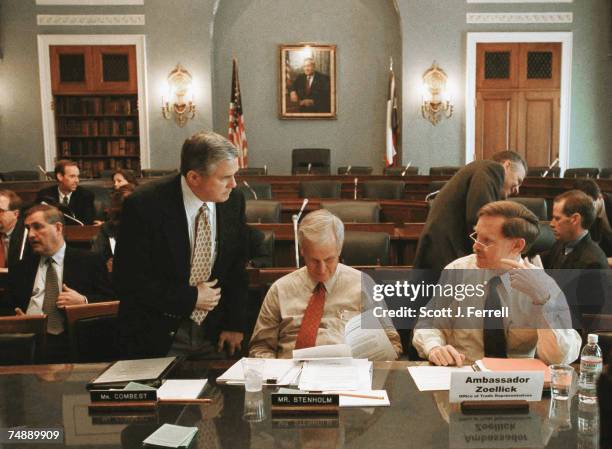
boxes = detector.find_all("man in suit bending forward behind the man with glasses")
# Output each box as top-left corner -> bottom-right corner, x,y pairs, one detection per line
414,151 -> 527,271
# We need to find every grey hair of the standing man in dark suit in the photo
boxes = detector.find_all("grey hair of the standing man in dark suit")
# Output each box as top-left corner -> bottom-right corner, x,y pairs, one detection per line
181,132 -> 239,176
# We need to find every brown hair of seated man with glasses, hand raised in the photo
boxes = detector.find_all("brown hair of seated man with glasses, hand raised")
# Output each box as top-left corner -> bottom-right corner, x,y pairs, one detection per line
478,201 -> 540,248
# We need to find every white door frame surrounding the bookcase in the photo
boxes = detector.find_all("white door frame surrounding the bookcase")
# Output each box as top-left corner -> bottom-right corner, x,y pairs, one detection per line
38,34 -> 151,170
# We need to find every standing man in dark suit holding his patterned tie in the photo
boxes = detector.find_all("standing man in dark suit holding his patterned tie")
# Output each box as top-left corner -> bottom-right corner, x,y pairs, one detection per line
113,132 -> 248,358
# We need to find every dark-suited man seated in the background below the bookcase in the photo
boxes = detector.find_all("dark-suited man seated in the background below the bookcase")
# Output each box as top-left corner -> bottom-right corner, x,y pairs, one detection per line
36,159 -> 94,225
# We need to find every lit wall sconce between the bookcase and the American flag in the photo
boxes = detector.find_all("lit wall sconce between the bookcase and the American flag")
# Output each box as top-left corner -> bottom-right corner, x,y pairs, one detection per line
162,64 -> 195,128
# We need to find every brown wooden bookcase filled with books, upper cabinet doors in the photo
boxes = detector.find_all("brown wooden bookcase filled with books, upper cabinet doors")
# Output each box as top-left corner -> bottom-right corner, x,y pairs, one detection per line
50,45 -> 140,177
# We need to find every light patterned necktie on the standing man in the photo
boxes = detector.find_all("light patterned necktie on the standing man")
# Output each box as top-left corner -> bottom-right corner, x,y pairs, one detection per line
189,204 -> 212,325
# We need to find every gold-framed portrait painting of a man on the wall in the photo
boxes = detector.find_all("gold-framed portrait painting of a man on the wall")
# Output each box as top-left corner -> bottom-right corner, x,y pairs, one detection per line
279,44 -> 336,119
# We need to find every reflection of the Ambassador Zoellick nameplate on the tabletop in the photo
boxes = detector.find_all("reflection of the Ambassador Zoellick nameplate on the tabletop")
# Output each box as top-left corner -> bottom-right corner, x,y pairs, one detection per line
449,412 -> 544,449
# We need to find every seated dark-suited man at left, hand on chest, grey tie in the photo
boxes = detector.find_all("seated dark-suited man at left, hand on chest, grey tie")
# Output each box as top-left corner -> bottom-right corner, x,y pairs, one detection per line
5,204 -> 113,363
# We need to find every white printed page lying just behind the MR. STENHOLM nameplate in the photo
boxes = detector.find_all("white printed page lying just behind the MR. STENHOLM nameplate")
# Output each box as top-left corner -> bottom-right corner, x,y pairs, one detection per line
298,359 -> 373,391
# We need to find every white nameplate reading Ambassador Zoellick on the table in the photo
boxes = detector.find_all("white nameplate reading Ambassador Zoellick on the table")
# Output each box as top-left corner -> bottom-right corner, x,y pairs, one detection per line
449,371 -> 544,402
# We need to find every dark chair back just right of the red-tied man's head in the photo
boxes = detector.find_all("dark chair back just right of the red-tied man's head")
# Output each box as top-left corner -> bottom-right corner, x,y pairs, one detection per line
340,231 -> 391,265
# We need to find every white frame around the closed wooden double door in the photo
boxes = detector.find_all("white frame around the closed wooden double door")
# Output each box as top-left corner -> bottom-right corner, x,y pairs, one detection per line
465,32 -> 573,170
